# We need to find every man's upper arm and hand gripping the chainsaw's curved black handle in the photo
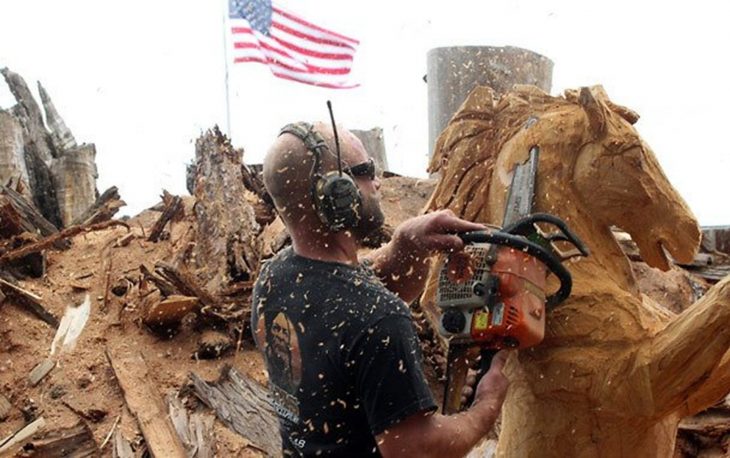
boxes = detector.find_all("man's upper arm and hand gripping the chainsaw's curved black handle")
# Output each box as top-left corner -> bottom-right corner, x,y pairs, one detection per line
366,210 -> 485,302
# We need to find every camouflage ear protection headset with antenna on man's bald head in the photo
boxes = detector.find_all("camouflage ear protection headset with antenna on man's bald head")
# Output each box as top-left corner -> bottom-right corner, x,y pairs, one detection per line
279,121 -> 362,232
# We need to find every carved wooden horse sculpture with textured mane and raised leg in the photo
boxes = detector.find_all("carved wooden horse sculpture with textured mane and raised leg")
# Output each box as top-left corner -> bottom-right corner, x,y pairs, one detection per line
422,86 -> 730,457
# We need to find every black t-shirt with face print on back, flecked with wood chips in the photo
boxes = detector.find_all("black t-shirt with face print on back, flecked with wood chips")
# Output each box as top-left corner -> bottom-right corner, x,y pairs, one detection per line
251,248 -> 436,457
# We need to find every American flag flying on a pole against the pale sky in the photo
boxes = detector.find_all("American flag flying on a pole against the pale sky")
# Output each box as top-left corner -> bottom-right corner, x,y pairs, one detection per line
228,0 -> 360,89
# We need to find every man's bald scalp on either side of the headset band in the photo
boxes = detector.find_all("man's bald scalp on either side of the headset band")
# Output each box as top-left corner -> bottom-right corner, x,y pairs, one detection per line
263,122 -> 367,227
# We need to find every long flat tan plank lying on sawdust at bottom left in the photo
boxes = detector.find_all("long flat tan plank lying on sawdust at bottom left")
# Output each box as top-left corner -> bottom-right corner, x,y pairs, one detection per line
106,347 -> 187,458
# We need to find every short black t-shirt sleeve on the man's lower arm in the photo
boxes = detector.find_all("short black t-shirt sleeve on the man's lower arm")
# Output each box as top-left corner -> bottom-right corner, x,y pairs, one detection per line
349,315 -> 436,436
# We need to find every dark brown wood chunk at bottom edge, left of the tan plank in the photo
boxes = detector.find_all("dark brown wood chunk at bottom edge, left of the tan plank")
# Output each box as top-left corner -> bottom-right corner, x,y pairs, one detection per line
20,422 -> 101,458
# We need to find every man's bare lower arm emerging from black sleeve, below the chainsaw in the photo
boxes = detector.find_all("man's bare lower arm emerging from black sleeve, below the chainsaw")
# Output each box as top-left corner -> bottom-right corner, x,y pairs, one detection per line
376,352 -> 509,458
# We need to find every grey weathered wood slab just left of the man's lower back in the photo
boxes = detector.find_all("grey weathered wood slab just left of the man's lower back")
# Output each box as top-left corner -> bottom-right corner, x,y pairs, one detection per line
190,366 -> 281,456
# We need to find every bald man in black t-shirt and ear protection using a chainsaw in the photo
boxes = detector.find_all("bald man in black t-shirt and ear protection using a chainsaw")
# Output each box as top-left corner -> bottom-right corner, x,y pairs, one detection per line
252,123 -> 507,457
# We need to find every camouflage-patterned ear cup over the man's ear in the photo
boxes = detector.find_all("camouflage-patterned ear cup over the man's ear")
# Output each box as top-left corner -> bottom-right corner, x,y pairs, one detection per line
314,172 -> 362,231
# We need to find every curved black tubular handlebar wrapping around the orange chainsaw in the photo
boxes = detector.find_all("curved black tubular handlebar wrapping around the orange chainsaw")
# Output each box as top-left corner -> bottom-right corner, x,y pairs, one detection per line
457,231 -> 573,308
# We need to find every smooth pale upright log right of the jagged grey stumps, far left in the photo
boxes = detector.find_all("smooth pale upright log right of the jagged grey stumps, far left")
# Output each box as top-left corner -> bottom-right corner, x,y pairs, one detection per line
51,144 -> 99,226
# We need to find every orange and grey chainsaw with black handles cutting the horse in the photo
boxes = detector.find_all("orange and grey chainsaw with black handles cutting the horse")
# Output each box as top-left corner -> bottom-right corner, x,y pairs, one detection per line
436,146 -> 588,414
